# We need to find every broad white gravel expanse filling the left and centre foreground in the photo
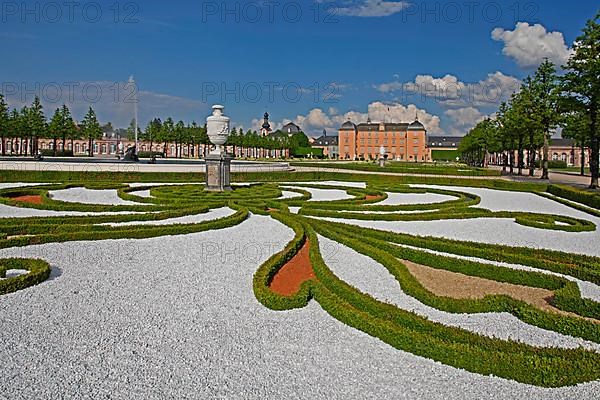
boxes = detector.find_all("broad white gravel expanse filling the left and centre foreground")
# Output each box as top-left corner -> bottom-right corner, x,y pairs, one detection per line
0,216 -> 600,400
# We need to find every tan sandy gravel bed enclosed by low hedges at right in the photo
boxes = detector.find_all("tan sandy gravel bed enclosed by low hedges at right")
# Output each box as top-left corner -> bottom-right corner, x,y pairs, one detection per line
401,260 -> 600,323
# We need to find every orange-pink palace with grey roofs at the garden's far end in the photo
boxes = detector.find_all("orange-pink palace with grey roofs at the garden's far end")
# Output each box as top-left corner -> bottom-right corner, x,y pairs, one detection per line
338,119 -> 430,162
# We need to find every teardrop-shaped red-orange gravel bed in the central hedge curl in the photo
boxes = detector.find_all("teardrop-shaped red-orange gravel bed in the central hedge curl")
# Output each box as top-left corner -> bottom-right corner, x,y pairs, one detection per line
269,240 -> 316,296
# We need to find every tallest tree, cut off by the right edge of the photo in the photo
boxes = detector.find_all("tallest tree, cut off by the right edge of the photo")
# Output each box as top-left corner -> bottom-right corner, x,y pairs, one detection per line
561,12 -> 600,189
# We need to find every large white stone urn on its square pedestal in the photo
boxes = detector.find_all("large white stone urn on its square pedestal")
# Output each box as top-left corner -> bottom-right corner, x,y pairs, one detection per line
206,105 -> 233,192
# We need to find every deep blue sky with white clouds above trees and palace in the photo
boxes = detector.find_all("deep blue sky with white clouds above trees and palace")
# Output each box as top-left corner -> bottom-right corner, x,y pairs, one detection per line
0,0 -> 599,136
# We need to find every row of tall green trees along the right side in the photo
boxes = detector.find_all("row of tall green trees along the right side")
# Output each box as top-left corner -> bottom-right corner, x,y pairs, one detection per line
459,13 -> 600,189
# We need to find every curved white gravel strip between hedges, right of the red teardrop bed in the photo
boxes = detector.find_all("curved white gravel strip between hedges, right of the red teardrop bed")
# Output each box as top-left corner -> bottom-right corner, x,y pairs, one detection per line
319,236 -> 600,352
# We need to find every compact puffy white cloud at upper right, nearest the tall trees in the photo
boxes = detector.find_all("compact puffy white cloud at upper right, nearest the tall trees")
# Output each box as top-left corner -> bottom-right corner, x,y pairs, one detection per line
492,22 -> 573,68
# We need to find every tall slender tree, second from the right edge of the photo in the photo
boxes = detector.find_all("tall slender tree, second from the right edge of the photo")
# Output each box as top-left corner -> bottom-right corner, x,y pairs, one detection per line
532,59 -> 560,179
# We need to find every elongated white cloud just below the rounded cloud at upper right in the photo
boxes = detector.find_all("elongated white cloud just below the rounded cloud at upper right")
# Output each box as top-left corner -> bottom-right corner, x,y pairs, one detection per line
375,71 -> 521,107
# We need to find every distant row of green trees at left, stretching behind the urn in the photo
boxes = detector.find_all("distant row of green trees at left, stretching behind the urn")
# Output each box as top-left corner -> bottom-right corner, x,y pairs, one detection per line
0,93 -> 310,158
